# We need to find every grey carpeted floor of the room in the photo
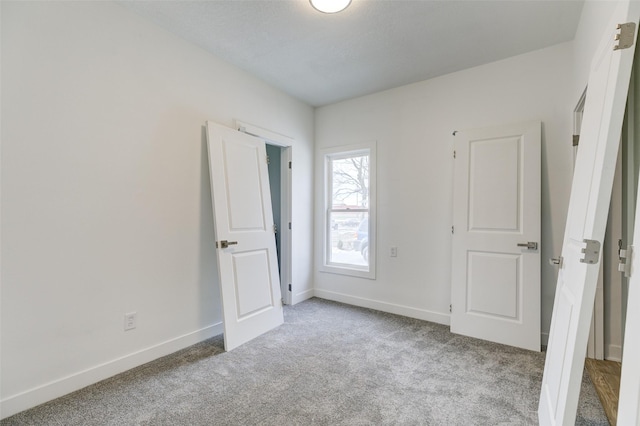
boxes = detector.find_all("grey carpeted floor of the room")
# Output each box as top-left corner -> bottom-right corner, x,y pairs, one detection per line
0,299 -> 608,426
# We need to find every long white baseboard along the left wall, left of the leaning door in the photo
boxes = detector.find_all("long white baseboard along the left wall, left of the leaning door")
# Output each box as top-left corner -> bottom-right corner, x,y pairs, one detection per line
0,322 -> 223,419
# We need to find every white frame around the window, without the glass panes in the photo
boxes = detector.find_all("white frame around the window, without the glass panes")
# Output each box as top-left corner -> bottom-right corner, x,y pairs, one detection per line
320,142 -> 377,280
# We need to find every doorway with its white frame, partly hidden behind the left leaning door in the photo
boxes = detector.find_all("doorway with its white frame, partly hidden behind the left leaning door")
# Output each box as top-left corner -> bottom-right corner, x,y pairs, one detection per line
235,120 -> 293,305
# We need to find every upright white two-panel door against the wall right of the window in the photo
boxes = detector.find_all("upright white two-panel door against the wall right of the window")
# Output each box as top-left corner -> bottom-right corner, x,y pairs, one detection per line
451,122 -> 541,351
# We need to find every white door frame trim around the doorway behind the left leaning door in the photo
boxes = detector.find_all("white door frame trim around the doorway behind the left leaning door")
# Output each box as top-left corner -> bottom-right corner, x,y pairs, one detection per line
235,120 -> 294,305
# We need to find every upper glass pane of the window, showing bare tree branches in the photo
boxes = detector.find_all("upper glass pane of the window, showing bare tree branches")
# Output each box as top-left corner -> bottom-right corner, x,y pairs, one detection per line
331,155 -> 369,209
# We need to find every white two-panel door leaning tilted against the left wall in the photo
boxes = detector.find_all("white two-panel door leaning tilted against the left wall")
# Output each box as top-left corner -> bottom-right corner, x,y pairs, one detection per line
207,121 -> 284,351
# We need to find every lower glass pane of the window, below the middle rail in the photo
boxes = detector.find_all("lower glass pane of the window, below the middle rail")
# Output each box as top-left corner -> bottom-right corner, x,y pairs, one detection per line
328,212 -> 369,267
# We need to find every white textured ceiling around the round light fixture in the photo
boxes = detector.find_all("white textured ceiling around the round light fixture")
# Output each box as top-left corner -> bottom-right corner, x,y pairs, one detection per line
120,0 -> 583,106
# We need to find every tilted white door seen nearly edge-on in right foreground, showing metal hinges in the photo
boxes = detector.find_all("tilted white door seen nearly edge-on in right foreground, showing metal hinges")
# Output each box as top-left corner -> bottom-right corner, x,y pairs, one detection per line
538,1 -> 640,425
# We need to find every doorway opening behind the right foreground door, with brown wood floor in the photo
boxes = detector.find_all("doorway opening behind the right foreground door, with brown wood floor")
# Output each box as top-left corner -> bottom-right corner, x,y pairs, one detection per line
574,38 -> 640,424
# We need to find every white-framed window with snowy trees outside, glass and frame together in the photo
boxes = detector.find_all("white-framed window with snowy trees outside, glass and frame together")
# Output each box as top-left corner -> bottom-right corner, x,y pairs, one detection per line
322,144 -> 375,279
